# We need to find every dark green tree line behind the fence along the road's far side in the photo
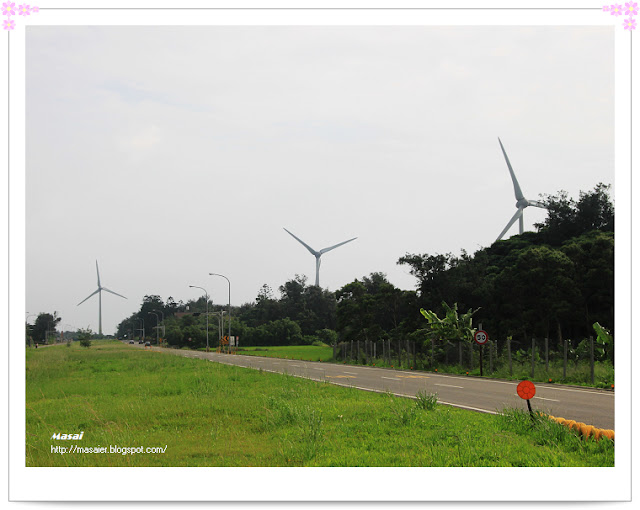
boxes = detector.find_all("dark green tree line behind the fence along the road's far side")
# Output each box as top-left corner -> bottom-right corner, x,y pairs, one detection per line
111,184 -> 614,358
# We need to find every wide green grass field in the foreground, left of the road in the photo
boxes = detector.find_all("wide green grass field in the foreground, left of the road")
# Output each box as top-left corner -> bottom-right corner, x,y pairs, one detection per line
25,341 -> 614,467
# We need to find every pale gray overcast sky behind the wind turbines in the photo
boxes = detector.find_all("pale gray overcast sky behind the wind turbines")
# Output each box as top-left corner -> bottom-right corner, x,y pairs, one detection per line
26,26 -> 614,333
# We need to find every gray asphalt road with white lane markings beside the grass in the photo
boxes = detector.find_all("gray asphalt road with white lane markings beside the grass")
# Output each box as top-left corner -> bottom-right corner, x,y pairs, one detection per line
130,344 -> 615,429
